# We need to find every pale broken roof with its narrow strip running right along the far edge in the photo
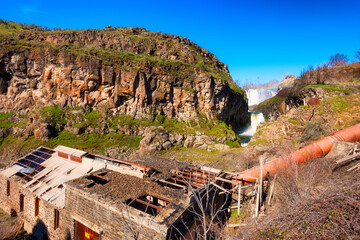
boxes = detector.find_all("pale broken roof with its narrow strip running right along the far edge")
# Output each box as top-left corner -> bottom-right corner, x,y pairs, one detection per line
0,146 -> 152,208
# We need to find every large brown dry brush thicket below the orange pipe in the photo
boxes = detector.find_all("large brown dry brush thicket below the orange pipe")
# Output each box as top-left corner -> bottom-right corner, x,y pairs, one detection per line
245,159 -> 360,239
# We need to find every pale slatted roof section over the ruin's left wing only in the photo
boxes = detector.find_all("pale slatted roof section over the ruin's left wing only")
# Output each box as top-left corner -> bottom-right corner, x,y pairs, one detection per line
0,146 -> 93,208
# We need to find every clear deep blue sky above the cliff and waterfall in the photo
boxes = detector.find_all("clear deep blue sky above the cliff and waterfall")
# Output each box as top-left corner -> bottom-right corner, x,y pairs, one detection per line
0,0 -> 360,85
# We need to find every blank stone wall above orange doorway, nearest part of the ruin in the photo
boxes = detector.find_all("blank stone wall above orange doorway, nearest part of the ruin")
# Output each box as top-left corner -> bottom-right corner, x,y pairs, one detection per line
65,185 -> 167,240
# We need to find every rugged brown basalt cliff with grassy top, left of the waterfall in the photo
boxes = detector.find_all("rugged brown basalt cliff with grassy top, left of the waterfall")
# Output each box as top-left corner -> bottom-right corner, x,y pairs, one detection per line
0,23 -> 249,128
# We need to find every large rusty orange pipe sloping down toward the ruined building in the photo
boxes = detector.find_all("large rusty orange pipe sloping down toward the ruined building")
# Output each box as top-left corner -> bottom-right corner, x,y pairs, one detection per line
234,123 -> 360,182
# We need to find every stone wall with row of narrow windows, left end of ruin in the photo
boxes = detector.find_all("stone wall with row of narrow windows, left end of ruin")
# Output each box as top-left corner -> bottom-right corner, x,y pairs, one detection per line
0,175 -> 67,240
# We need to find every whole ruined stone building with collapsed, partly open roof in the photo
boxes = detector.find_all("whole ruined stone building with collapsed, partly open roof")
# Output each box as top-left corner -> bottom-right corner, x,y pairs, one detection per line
0,146 -> 228,240
